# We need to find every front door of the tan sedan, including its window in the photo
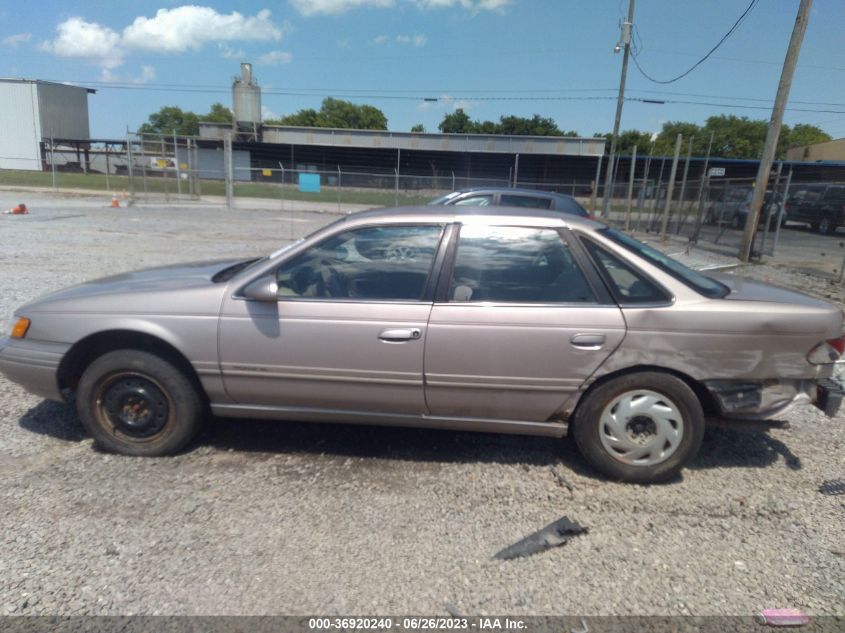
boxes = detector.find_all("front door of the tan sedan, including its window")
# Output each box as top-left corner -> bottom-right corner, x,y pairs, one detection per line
219,225 -> 442,415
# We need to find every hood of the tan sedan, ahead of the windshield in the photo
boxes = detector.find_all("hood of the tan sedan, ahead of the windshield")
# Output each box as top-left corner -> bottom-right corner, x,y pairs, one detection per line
20,259 -> 244,312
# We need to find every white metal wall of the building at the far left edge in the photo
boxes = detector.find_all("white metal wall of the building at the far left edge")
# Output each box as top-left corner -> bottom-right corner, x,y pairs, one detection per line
0,82 -> 41,170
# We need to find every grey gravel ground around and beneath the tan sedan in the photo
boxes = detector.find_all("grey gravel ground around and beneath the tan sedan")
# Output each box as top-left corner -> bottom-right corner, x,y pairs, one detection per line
0,194 -> 845,615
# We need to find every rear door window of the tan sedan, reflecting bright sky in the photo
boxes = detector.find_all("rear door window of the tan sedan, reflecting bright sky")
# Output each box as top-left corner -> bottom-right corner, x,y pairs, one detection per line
449,226 -> 596,303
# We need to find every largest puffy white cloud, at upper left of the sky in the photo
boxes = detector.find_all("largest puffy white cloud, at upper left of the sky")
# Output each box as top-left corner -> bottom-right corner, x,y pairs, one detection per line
41,5 -> 287,69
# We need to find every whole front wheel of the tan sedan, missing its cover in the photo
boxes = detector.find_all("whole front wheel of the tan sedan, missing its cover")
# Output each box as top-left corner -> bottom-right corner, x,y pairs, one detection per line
76,349 -> 205,457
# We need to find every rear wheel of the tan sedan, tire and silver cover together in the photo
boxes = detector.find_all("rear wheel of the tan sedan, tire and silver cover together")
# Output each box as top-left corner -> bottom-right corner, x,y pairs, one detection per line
573,372 -> 704,483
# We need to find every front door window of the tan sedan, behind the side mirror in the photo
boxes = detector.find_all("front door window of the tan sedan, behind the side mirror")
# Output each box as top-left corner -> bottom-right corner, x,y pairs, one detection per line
276,225 -> 442,301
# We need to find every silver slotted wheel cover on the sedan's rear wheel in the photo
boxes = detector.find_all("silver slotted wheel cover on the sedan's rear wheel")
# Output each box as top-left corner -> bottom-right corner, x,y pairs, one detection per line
599,389 -> 684,466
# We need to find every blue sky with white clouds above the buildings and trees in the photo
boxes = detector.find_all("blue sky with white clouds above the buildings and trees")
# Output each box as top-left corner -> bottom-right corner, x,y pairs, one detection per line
0,0 -> 845,138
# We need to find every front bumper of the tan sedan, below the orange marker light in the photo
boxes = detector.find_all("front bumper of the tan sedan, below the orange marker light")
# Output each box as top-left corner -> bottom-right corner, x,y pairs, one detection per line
0,337 -> 70,401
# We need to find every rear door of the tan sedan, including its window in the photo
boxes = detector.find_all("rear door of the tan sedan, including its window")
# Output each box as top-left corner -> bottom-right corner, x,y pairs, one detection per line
425,224 -> 625,421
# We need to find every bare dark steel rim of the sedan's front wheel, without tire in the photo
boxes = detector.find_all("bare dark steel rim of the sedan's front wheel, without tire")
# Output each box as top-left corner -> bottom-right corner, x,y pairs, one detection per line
97,372 -> 170,440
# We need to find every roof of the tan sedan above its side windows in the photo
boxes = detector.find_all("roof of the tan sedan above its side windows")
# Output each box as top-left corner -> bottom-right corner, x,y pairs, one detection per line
336,205 -> 602,228
